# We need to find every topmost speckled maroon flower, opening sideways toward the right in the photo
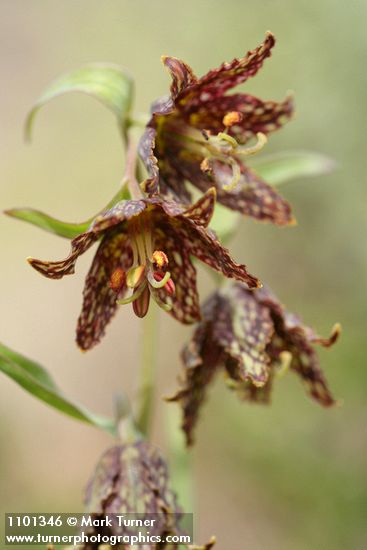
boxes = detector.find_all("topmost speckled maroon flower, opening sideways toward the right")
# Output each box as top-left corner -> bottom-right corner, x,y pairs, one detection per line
139,33 -> 294,225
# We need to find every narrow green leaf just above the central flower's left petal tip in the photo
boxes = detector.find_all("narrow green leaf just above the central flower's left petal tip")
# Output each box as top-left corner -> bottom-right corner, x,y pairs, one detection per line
4,185 -> 129,239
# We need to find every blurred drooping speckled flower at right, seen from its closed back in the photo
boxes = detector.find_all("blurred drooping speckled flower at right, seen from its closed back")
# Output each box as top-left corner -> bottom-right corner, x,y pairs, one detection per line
169,283 -> 340,444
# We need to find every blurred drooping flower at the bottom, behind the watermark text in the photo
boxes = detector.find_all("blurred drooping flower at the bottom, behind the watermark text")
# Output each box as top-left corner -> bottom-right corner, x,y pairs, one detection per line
52,442 -> 216,550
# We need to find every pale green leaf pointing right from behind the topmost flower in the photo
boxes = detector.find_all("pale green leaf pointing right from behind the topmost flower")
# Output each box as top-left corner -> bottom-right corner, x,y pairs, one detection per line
252,151 -> 335,186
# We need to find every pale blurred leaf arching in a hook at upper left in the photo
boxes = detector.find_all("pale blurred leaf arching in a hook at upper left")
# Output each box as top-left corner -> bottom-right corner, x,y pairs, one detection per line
25,63 -> 133,140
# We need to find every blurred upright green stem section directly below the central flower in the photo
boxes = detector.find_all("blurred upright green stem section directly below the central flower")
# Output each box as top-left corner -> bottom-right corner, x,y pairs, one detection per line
136,304 -> 159,436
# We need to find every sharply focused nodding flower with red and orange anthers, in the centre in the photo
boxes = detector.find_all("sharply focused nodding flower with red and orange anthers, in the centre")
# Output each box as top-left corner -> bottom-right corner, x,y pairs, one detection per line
28,189 -> 260,350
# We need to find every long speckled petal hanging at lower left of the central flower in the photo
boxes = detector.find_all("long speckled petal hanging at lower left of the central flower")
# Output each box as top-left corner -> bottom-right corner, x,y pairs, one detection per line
76,232 -> 132,350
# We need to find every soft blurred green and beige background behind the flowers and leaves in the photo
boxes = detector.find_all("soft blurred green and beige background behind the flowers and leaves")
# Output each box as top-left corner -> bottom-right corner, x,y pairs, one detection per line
0,0 -> 367,550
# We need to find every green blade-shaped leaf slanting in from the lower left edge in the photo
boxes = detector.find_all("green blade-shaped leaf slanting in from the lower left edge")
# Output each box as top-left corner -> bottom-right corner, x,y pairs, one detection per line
0,344 -> 116,435
